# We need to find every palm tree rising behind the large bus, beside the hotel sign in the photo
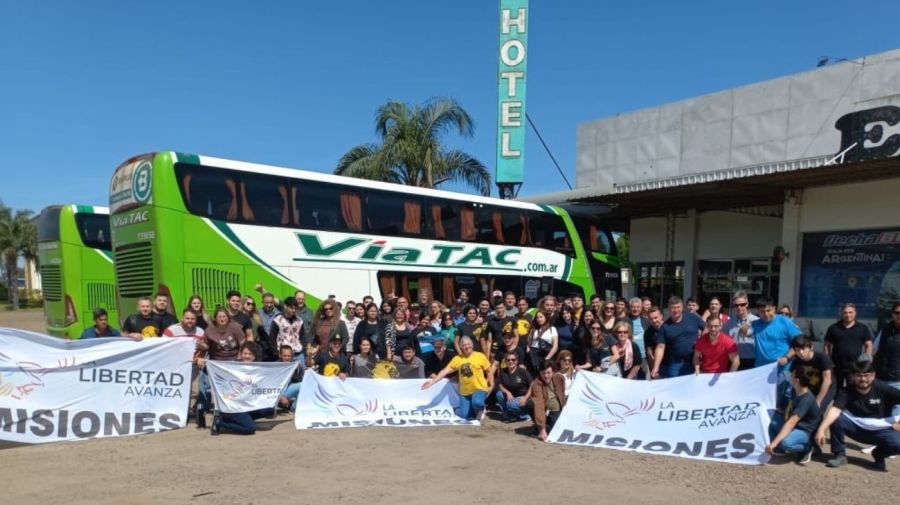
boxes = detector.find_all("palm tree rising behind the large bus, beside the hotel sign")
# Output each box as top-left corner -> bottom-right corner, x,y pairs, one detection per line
334,98 -> 491,196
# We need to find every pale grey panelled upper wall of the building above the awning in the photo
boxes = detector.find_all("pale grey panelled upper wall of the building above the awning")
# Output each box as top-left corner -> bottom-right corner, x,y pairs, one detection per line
576,50 -> 900,192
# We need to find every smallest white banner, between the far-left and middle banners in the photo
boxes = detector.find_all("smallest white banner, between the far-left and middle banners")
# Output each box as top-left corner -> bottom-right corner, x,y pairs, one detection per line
206,360 -> 300,414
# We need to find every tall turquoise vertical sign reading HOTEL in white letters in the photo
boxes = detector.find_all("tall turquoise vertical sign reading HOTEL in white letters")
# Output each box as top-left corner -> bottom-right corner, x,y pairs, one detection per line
496,0 -> 528,183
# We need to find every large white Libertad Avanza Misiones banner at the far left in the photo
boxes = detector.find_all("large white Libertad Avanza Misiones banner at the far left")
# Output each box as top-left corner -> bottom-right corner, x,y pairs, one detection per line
0,328 -> 195,443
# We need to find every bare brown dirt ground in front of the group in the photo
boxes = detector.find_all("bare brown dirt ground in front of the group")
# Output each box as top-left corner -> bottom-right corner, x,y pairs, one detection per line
0,312 -> 900,505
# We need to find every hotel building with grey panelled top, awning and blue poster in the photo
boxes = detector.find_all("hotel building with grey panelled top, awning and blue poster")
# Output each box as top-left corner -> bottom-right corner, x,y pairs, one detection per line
529,50 -> 900,334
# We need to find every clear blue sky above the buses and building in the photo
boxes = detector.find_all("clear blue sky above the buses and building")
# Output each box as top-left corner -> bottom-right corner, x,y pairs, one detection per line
0,0 -> 900,211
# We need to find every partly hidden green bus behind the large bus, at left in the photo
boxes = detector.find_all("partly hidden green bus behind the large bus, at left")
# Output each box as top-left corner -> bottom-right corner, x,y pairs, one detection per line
38,205 -> 118,339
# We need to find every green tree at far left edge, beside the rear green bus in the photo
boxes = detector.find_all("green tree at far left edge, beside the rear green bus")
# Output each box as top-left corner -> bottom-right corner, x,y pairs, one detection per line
0,202 -> 37,310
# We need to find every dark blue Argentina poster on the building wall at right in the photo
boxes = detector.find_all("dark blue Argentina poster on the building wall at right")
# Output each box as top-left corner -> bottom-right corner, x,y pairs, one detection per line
799,228 -> 900,319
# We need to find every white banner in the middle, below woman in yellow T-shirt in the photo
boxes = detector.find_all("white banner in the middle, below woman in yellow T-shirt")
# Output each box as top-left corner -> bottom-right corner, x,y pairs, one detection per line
294,373 -> 480,430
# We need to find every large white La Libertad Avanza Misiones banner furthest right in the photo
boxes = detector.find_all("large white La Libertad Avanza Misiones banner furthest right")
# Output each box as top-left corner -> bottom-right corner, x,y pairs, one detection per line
547,363 -> 776,465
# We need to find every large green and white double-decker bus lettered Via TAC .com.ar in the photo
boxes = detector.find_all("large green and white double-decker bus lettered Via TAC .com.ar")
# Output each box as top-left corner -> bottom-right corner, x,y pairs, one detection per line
110,152 -> 621,312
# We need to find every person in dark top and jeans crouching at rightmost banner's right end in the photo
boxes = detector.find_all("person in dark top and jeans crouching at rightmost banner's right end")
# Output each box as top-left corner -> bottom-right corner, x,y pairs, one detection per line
766,366 -> 822,465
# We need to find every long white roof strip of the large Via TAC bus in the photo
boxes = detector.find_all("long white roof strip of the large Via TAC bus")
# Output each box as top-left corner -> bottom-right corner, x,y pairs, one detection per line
158,152 -> 545,211
